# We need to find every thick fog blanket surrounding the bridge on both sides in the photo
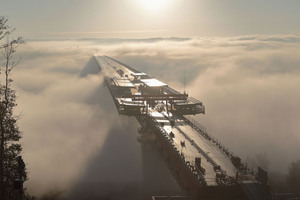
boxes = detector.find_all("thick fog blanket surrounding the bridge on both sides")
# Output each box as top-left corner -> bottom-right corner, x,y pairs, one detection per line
13,35 -> 300,198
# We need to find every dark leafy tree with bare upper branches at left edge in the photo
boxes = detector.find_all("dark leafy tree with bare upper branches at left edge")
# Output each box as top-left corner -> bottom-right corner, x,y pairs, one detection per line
0,17 -> 26,200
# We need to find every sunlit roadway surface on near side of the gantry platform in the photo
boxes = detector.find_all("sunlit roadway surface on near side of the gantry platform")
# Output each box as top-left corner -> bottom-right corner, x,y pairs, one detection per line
149,109 -> 237,186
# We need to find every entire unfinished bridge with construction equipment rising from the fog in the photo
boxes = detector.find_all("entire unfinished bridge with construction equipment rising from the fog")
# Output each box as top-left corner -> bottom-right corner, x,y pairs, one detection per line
95,56 -> 267,199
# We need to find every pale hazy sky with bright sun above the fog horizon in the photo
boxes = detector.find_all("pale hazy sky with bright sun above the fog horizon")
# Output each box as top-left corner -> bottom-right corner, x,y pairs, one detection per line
0,0 -> 300,38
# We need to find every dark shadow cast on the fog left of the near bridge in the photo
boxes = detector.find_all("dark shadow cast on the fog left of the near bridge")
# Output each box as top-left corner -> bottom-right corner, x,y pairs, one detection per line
70,115 -> 142,199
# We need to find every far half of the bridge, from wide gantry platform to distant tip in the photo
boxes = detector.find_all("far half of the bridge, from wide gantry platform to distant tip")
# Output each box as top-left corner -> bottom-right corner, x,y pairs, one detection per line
97,57 -> 205,115
